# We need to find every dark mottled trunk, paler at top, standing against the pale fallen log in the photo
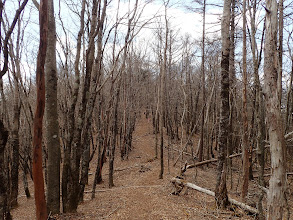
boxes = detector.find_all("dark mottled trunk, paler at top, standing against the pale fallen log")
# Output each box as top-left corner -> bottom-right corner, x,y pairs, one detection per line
215,0 -> 231,208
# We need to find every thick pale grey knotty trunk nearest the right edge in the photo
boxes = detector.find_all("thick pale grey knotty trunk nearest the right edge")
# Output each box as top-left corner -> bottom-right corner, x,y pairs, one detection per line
264,0 -> 286,220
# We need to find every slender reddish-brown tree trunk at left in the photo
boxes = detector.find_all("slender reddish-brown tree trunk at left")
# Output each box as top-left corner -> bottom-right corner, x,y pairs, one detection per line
33,0 -> 48,220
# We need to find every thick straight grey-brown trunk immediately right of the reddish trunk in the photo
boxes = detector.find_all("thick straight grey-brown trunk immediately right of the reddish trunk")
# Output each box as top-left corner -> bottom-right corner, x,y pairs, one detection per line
45,0 -> 60,214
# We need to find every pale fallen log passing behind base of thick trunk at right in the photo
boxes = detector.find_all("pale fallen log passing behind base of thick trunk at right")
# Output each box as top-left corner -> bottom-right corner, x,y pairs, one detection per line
171,178 -> 258,214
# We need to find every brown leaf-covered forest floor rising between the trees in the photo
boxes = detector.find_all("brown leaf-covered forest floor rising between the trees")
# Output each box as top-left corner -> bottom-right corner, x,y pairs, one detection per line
12,114 -> 292,220
